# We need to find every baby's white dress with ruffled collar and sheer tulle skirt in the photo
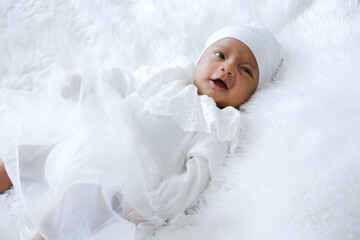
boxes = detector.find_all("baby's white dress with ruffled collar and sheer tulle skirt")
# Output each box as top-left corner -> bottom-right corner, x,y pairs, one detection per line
0,62 -> 240,239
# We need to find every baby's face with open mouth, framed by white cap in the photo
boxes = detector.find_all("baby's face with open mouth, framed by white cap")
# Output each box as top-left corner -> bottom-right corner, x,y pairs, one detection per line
194,38 -> 259,108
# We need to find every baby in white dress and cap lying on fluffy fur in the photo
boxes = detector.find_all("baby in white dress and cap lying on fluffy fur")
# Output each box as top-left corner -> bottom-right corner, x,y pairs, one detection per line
0,23 -> 281,239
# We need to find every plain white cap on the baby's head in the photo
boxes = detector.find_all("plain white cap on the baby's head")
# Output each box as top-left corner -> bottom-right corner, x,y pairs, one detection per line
198,22 -> 282,88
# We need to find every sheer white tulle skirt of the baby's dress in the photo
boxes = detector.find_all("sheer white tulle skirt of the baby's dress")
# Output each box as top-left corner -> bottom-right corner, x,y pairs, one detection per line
0,70 -> 162,239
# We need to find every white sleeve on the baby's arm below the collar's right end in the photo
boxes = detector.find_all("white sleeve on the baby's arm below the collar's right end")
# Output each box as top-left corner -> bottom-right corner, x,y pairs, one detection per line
149,133 -> 228,218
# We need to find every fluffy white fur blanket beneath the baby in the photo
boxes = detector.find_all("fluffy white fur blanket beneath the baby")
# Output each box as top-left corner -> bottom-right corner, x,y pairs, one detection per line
0,0 -> 360,240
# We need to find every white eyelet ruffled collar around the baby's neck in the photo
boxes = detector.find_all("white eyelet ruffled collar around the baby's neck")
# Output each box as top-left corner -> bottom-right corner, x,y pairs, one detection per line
136,65 -> 241,152
